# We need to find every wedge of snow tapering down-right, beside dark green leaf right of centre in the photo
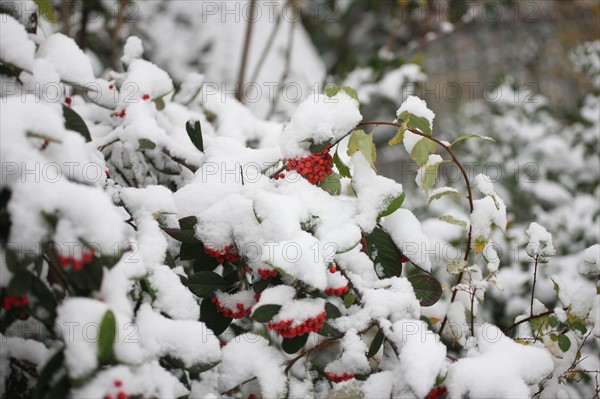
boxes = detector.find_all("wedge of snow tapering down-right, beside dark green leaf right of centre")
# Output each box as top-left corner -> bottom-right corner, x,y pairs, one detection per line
381,209 -> 431,271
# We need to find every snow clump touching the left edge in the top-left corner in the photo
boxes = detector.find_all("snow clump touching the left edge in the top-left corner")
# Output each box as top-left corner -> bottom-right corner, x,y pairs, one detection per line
0,14 -> 35,70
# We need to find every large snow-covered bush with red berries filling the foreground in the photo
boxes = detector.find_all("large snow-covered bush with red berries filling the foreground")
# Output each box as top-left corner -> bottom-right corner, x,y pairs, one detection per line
0,16 -> 600,399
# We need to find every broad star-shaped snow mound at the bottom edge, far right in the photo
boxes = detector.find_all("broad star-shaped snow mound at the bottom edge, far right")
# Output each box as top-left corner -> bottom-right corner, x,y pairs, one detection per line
446,324 -> 553,398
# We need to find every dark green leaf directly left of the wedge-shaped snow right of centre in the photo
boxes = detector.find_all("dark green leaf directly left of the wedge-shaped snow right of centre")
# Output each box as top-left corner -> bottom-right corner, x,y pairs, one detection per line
365,227 -> 402,278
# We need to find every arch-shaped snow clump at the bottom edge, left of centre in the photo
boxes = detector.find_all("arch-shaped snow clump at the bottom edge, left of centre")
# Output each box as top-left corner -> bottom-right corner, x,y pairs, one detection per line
219,334 -> 287,398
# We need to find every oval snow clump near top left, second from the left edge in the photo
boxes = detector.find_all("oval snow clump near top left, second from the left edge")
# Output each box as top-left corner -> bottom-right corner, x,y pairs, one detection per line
37,33 -> 95,86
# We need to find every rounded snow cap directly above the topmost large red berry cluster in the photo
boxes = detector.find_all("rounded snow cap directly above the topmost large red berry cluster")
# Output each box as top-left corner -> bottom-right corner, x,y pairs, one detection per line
279,91 -> 362,158
